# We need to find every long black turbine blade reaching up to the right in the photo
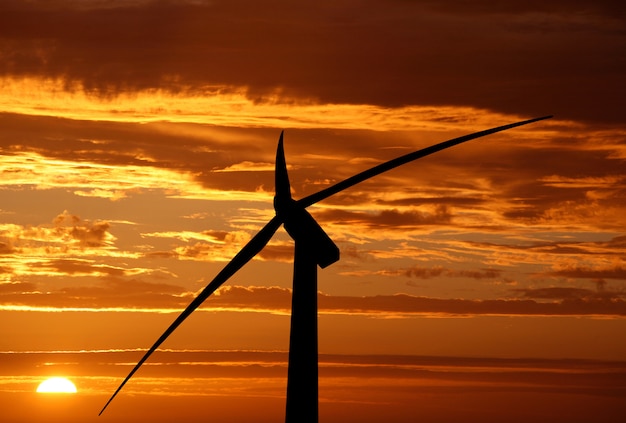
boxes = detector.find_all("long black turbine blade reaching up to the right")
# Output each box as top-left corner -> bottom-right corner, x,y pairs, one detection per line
297,115 -> 552,207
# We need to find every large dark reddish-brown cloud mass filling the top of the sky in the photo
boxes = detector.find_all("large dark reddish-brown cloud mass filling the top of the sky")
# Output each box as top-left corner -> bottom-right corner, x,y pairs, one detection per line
0,0 -> 626,122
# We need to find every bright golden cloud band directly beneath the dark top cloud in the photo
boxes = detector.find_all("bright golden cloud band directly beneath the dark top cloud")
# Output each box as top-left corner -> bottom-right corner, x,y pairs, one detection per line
0,75 -> 504,132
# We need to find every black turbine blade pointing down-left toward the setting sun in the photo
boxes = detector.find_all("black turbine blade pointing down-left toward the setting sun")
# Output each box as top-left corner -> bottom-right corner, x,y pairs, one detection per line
98,216 -> 282,415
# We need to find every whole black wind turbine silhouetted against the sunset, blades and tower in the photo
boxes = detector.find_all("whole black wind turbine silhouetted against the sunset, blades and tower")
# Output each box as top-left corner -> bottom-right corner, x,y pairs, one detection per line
98,116 -> 552,423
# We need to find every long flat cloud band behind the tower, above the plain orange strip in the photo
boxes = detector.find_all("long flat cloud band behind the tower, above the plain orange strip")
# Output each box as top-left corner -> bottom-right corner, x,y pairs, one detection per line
0,277 -> 626,318
